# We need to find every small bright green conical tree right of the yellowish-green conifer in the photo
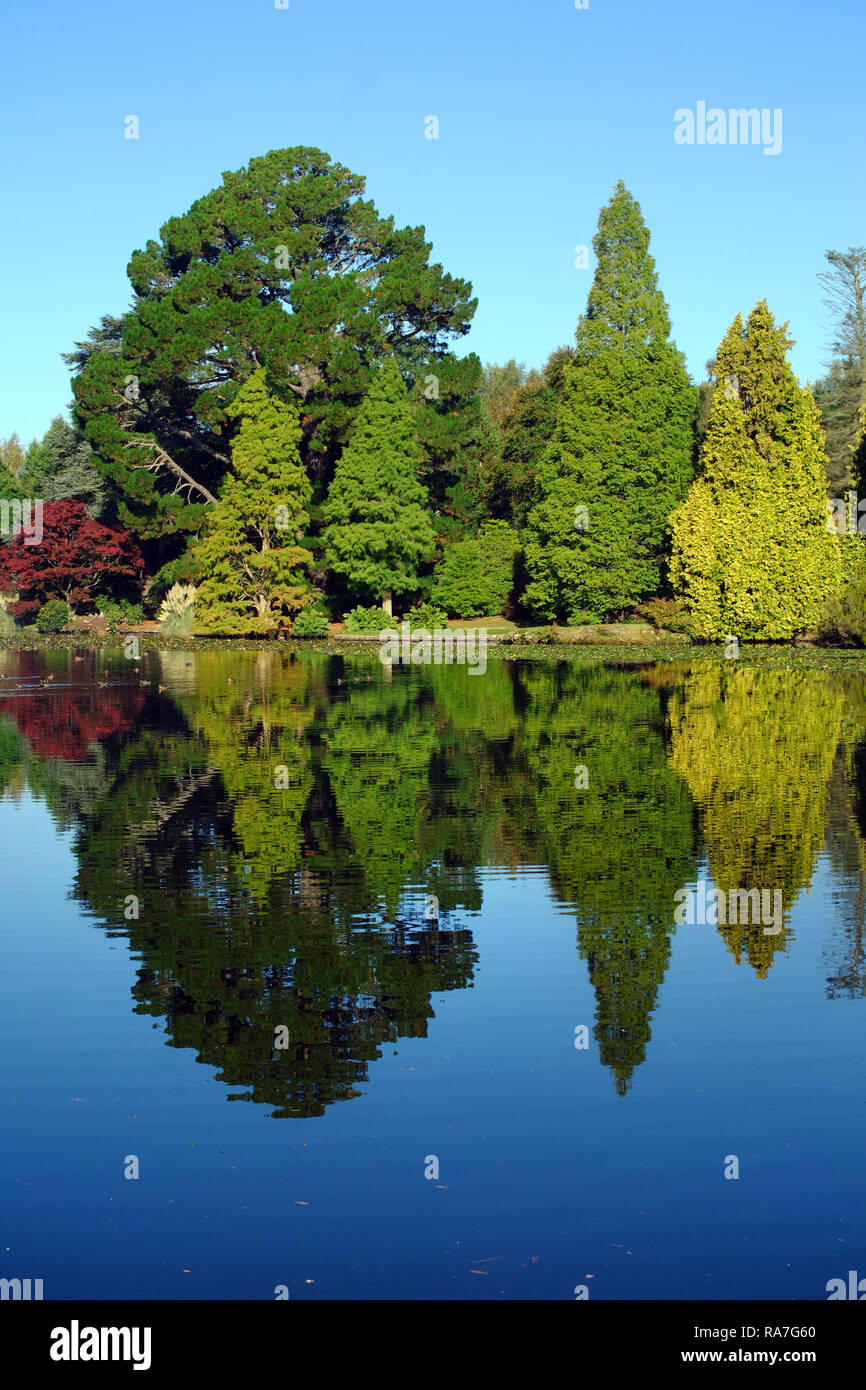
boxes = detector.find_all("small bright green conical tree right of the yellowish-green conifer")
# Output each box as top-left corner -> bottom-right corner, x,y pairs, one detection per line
324,360 -> 434,613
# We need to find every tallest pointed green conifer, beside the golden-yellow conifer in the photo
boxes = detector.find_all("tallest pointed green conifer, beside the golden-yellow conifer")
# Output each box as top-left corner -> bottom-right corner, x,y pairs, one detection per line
524,182 -> 696,623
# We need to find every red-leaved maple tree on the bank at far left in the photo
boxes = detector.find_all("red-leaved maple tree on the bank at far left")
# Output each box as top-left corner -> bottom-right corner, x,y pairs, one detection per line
0,498 -> 145,617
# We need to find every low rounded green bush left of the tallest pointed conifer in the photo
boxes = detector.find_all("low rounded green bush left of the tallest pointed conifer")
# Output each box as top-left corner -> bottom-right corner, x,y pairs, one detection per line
432,521 -> 520,617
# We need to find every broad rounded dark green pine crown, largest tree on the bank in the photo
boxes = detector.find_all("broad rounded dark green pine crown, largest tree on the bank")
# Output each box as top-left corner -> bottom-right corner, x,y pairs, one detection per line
70,146 -> 480,538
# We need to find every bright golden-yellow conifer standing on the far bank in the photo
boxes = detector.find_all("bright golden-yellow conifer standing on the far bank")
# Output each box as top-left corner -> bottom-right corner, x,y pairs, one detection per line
671,300 -> 840,641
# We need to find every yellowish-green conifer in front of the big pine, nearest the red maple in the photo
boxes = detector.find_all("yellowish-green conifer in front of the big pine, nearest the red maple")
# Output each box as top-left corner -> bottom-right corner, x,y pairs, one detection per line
196,368 -> 313,632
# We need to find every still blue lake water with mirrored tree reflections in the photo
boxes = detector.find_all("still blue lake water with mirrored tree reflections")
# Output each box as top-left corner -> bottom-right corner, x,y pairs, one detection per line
0,649 -> 866,1300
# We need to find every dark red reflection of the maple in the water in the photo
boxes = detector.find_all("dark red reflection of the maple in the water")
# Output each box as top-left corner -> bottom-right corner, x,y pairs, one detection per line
0,653 -> 145,762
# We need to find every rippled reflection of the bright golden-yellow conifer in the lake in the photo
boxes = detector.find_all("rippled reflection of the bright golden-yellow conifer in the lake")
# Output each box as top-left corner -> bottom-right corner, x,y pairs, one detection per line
669,663 -> 844,976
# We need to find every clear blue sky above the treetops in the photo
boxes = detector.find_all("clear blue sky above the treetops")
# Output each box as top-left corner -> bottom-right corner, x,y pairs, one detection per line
0,0 -> 866,442
